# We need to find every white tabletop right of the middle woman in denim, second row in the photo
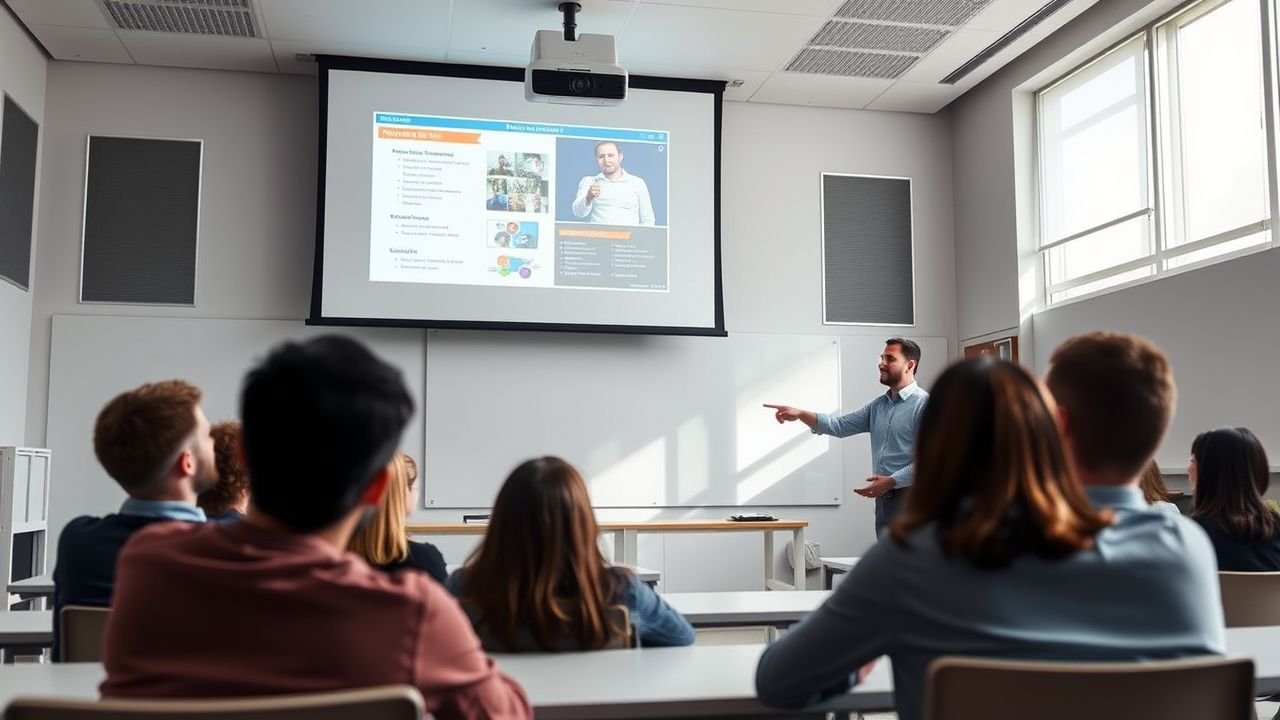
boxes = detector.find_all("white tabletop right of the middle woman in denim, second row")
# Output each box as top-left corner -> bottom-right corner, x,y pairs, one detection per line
662,591 -> 831,628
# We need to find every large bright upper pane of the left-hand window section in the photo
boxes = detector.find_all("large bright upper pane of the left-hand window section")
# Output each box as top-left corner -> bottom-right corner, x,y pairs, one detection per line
1039,38 -> 1149,242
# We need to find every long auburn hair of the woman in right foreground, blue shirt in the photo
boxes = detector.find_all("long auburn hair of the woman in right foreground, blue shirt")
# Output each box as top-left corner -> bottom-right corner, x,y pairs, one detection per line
890,359 -> 1110,568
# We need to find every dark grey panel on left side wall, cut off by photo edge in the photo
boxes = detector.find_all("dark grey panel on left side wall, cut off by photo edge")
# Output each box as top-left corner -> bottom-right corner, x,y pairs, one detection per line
0,95 -> 40,290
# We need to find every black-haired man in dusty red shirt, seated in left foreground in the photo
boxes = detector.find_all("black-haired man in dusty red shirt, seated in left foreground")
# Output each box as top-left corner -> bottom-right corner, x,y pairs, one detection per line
101,336 -> 531,719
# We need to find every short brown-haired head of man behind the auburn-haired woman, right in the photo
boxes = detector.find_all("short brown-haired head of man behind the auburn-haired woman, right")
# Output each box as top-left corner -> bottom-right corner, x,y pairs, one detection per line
1044,332 -> 1178,478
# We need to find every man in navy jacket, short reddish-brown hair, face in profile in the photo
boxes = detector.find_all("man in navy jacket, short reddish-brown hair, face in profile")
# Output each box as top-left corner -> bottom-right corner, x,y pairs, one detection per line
52,380 -> 218,660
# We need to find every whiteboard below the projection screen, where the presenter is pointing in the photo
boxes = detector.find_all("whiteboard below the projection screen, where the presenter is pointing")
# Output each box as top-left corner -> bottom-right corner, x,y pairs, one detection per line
424,331 -> 849,507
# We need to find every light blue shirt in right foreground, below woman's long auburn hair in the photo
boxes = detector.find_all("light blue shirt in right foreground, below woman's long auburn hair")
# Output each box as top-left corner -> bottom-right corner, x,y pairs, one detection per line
755,487 -> 1226,720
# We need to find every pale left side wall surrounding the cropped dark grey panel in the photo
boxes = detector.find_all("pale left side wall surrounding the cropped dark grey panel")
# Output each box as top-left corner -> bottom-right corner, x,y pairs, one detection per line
0,9 -> 49,445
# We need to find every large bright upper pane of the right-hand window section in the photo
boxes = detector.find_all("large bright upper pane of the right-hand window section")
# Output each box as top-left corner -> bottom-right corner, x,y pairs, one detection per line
1170,0 -> 1268,245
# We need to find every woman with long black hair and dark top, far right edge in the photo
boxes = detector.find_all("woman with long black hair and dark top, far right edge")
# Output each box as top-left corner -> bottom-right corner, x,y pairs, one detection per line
1187,428 -> 1280,573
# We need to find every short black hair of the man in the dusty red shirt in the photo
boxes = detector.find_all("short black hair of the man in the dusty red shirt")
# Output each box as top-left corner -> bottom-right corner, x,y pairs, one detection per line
241,336 -> 413,532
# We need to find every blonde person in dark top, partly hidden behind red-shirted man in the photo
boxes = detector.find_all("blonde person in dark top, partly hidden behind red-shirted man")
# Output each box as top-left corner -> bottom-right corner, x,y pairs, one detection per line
347,452 -> 449,583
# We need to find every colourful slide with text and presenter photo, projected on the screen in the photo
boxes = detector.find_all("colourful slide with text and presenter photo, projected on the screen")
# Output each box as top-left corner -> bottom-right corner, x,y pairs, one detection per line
369,111 -> 671,292
